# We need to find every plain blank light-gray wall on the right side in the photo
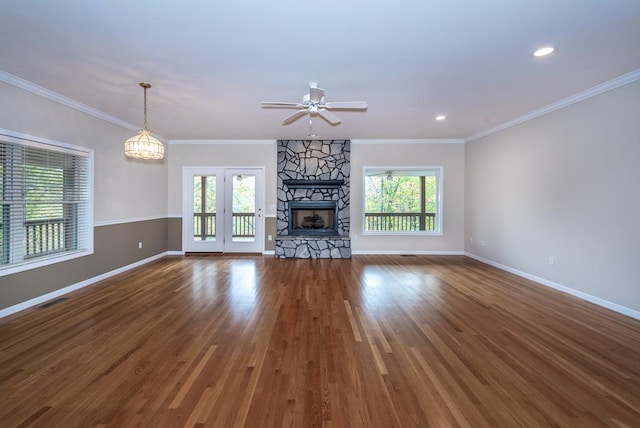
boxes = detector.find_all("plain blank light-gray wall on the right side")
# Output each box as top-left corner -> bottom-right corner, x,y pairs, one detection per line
465,81 -> 640,312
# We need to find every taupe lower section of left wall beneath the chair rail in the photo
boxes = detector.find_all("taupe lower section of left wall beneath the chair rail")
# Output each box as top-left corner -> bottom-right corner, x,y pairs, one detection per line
0,218 -> 168,309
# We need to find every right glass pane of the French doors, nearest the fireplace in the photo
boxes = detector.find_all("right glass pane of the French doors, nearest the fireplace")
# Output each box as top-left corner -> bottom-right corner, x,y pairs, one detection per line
231,174 -> 256,242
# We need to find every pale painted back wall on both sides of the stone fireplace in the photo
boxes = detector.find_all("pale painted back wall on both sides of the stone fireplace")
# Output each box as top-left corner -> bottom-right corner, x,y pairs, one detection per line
168,140 -> 464,253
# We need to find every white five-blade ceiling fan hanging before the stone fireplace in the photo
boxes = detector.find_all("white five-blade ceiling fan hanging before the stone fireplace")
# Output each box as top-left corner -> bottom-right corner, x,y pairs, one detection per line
262,82 -> 367,125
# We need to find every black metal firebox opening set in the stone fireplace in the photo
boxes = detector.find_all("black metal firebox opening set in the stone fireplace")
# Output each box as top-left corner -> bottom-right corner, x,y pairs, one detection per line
288,201 -> 338,235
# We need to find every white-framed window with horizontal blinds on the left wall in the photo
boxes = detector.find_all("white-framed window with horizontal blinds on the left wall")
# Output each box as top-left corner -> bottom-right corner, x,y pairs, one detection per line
0,135 -> 93,275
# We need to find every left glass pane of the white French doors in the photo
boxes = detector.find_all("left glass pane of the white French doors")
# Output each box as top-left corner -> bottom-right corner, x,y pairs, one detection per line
193,175 -> 216,241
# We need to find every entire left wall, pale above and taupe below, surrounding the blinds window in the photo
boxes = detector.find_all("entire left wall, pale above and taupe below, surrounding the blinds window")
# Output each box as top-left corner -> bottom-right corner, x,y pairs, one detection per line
0,77 -> 170,309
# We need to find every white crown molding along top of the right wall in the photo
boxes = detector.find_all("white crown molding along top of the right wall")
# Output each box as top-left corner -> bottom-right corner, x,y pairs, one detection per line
464,69 -> 640,143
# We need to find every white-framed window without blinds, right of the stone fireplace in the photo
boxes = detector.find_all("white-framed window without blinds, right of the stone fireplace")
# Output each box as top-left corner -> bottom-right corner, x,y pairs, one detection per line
363,167 -> 442,235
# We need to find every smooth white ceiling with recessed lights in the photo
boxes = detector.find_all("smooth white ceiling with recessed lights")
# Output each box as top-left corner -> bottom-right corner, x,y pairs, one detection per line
0,0 -> 640,139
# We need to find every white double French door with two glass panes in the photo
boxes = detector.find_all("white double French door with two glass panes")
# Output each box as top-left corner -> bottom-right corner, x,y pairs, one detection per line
182,167 -> 264,253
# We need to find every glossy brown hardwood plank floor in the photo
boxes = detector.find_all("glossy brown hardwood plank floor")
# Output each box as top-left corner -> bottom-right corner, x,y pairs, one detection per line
0,256 -> 640,427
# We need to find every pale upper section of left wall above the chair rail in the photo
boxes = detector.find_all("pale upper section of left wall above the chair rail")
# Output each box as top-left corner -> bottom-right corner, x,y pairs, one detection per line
0,81 -> 168,224
